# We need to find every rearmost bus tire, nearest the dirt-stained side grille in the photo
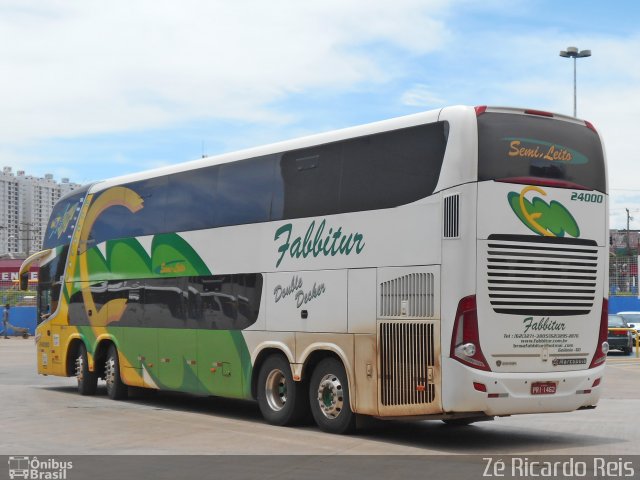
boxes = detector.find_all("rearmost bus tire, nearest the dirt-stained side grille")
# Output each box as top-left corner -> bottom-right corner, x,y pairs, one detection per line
309,358 -> 356,434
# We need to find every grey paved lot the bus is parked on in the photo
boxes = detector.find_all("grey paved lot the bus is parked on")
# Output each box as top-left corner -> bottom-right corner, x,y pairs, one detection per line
0,338 -> 640,455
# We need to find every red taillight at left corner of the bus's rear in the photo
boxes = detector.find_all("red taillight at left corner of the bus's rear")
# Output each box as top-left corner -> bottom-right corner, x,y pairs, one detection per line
450,295 -> 491,371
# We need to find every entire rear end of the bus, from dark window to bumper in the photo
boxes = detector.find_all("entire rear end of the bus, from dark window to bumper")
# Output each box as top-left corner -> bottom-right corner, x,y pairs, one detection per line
445,108 -> 608,415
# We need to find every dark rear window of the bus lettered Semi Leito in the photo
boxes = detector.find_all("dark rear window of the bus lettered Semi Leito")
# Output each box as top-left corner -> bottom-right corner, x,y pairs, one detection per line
478,112 -> 606,193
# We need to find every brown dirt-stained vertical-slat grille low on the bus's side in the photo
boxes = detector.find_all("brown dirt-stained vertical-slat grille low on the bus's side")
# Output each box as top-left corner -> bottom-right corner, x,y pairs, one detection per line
380,322 -> 436,406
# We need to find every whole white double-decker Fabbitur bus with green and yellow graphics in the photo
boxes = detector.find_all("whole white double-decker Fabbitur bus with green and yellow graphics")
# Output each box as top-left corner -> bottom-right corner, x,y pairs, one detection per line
22,107 -> 608,433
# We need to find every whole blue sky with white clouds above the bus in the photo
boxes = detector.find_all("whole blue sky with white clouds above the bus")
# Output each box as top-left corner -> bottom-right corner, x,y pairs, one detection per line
0,0 -> 640,228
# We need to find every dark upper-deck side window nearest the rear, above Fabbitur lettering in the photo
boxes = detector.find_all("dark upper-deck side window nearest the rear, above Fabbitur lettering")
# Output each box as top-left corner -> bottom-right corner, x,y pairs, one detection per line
274,122 -> 447,219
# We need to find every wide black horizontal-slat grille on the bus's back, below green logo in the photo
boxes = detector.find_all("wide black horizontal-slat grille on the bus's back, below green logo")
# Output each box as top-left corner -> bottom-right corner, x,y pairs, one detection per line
487,235 -> 598,316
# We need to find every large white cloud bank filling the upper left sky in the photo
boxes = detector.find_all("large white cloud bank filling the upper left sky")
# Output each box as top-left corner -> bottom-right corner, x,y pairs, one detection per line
0,0 -> 449,142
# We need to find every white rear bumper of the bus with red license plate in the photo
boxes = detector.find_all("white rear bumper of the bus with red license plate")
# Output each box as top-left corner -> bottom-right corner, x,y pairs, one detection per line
442,360 -> 605,416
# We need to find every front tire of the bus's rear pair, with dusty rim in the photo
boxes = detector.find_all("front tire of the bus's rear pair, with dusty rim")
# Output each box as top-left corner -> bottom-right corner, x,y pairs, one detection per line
257,355 -> 309,426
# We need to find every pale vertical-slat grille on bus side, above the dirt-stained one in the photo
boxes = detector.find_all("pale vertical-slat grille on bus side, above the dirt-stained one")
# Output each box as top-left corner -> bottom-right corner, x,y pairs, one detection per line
380,273 -> 435,318
